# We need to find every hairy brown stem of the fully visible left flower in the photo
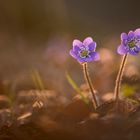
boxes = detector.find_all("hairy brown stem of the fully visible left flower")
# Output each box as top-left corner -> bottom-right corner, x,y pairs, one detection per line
83,63 -> 98,109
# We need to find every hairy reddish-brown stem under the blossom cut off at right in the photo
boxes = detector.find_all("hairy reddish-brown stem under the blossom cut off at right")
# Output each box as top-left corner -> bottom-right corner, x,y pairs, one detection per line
114,54 -> 128,101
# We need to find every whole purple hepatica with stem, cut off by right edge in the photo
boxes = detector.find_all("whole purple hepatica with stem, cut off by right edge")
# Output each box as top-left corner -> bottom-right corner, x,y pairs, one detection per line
114,28 -> 140,102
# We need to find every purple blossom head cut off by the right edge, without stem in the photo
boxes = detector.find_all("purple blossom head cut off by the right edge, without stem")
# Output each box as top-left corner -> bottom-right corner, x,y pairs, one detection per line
117,28 -> 140,55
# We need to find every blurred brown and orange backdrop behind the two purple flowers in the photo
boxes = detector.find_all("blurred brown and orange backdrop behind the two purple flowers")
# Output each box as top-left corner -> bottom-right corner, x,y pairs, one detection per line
0,0 -> 140,96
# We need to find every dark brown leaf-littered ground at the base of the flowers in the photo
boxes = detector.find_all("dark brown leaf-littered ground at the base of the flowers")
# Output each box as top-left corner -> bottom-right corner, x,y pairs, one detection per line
0,92 -> 140,140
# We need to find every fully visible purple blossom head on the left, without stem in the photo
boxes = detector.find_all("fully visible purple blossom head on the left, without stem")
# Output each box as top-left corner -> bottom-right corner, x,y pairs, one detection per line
70,37 -> 100,63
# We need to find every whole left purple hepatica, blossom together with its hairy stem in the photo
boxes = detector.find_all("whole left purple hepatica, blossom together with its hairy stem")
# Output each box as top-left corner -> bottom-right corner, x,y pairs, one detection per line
70,37 -> 100,109
